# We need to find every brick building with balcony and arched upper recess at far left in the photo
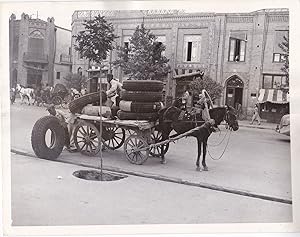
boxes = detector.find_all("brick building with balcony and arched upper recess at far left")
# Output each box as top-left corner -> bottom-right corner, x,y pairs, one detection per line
9,13 -> 72,87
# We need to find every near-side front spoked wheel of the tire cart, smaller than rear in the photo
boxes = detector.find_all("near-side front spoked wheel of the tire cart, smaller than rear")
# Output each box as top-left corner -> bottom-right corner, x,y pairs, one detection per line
124,135 -> 149,165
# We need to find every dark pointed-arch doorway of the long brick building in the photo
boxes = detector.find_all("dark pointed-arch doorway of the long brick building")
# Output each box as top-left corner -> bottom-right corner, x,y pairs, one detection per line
226,75 -> 244,108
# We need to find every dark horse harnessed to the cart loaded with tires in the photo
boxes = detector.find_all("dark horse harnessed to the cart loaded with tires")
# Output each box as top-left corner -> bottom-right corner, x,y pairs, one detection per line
157,106 -> 239,171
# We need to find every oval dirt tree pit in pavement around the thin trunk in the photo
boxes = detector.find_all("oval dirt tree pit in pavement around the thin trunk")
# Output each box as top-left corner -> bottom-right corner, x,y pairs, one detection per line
73,170 -> 127,181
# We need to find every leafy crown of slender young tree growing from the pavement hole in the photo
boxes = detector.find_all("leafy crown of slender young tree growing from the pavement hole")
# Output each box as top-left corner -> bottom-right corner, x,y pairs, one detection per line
73,15 -> 118,64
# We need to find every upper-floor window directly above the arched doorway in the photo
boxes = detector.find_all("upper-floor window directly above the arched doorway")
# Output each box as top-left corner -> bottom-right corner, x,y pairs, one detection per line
228,37 -> 246,62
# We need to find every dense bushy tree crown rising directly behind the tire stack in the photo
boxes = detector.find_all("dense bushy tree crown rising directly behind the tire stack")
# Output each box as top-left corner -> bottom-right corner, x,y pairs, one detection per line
114,24 -> 170,80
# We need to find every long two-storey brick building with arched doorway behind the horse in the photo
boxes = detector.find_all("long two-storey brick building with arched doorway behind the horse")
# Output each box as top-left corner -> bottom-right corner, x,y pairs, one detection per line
72,9 -> 289,121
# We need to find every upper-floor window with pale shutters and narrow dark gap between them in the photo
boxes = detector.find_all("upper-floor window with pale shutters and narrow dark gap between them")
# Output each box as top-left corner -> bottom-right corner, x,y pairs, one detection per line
183,35 -> 201,62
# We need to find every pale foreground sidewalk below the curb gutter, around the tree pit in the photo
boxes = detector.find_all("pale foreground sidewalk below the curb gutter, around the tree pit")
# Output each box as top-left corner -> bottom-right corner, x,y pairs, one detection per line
12,155 -> 292,226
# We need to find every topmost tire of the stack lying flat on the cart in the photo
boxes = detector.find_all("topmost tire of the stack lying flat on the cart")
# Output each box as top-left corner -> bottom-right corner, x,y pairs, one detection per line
122,80 -> 164,92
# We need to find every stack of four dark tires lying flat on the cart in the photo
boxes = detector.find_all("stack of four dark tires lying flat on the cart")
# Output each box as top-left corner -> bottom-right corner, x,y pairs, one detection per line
118,80 -> 164,121
